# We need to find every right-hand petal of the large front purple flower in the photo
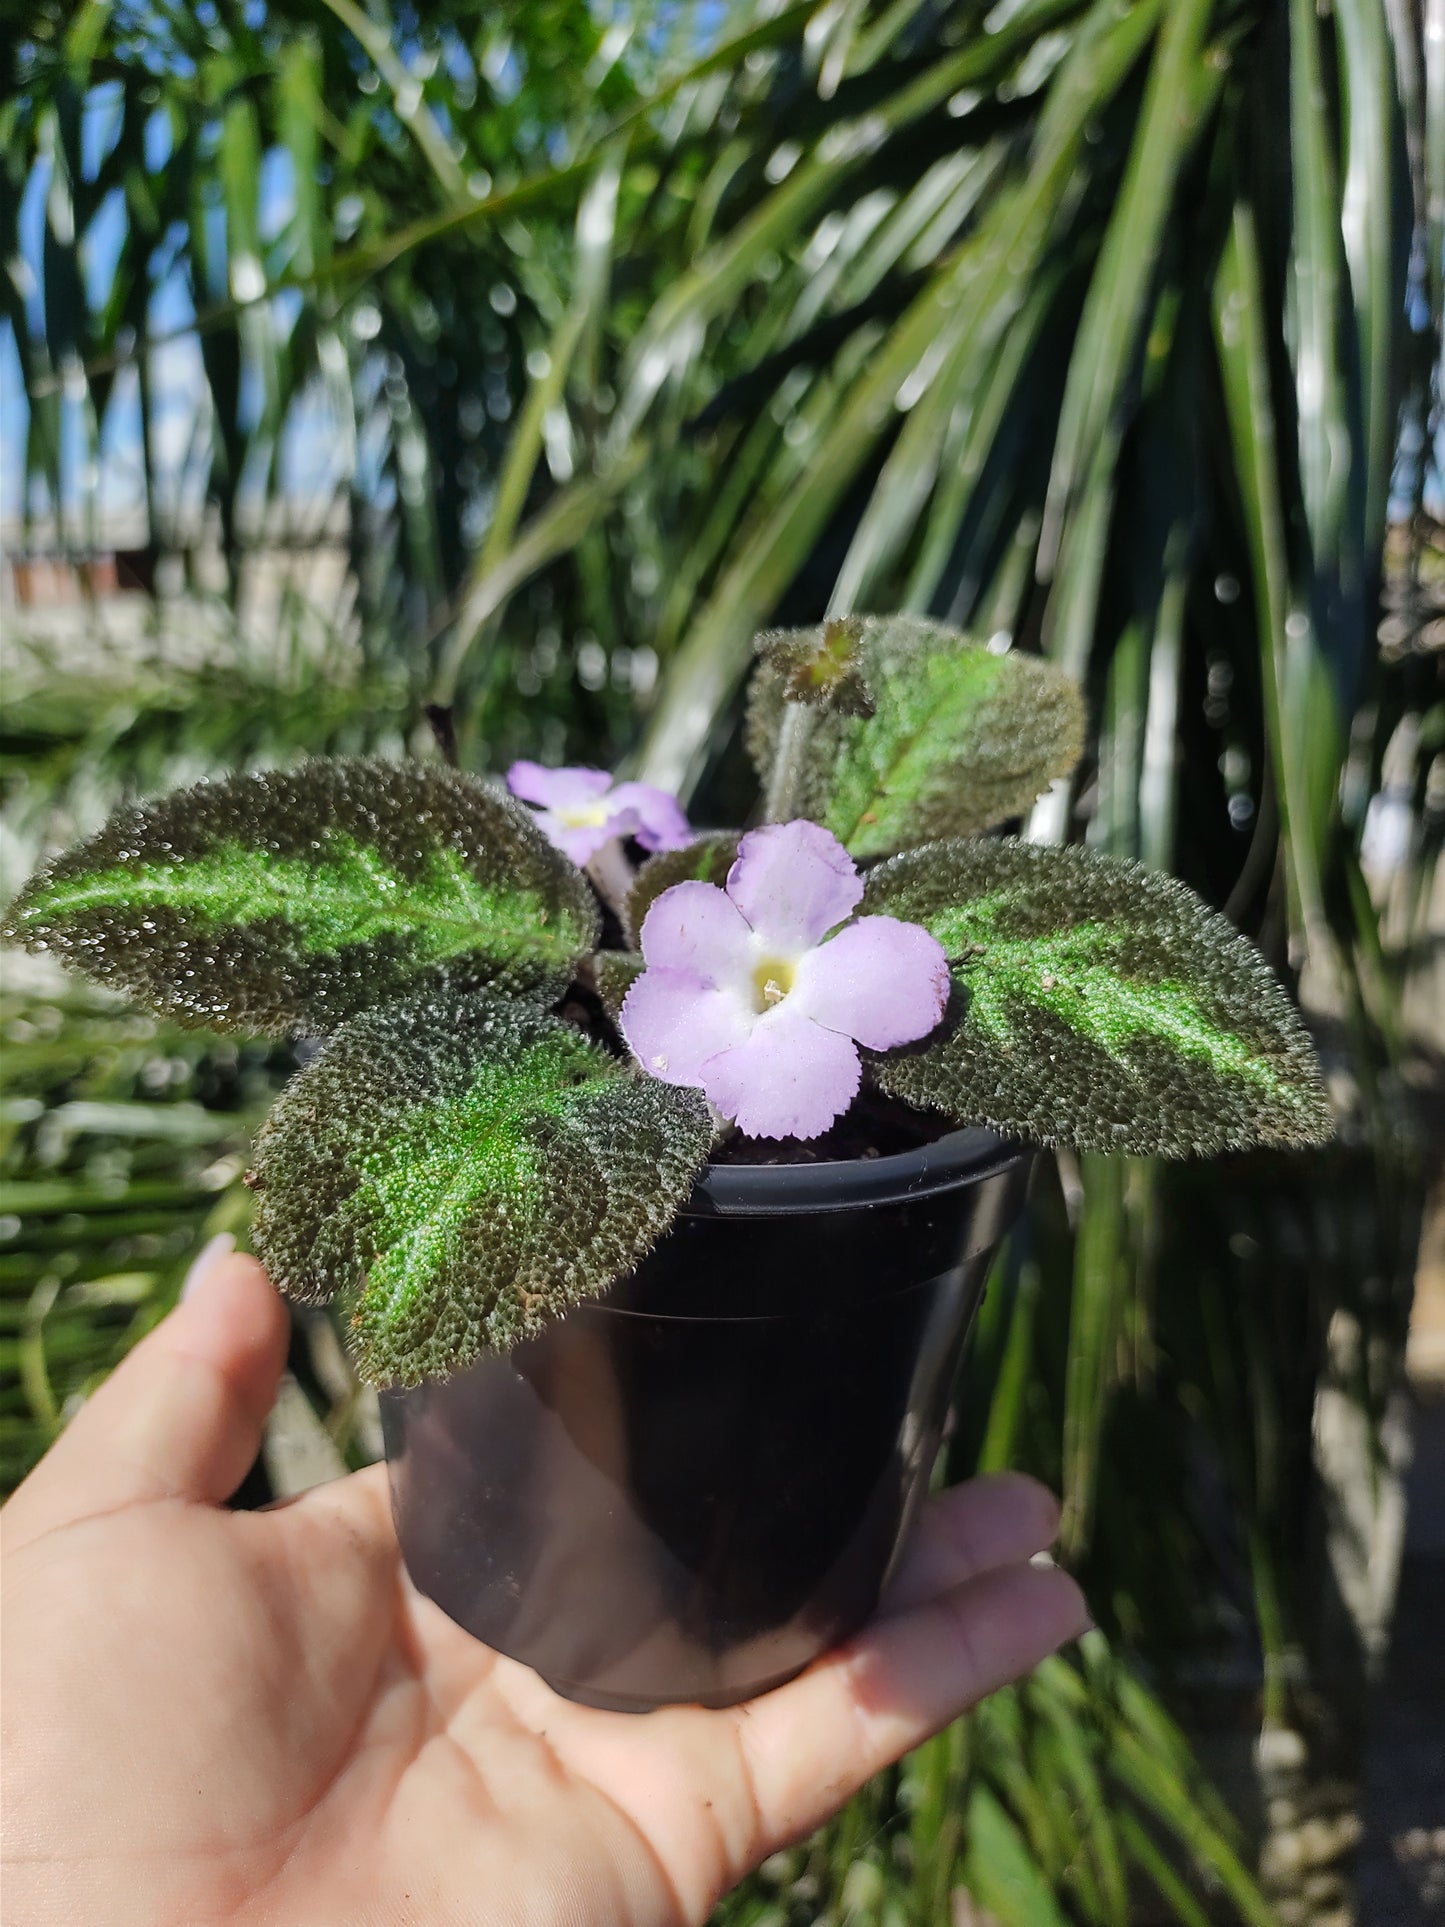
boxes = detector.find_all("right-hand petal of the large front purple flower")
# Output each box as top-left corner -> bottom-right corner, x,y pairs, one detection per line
788,917 -> 948,1050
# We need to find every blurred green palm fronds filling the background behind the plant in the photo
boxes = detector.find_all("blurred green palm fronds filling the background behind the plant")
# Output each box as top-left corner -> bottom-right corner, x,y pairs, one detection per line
0,0 -> 1445,1927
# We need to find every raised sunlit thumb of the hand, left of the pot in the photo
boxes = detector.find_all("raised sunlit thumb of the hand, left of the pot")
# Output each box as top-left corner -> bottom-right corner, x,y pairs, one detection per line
10,1243 -> 289,1532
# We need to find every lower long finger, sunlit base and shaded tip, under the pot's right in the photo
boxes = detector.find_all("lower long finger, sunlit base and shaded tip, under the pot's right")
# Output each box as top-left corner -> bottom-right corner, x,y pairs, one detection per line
730,1565 -> 1090,1863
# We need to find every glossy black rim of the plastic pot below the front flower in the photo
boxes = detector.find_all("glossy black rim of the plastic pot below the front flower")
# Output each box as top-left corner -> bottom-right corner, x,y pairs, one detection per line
680,1125 -> 1035,1218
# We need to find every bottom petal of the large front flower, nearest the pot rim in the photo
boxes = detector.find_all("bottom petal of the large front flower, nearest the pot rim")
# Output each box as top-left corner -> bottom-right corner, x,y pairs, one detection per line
701,1004 -> 863,1137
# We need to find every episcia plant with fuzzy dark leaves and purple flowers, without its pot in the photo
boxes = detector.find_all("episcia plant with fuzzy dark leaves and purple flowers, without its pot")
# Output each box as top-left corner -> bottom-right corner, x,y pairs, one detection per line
4,617 -> 1331,1386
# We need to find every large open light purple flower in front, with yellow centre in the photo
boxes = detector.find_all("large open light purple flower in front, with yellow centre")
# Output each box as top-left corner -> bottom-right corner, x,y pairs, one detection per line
622,823 -> 948,1137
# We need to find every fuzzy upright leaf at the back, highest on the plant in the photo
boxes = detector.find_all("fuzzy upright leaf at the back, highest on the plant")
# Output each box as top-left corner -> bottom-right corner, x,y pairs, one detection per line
748,617 -> 1083,858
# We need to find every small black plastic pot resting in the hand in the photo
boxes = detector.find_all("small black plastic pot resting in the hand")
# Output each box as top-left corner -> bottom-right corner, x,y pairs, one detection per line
381,1131 -> 1029,1711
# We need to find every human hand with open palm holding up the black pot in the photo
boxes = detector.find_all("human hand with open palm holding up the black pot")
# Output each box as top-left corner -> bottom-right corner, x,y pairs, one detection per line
0,1256 -> 1087,1927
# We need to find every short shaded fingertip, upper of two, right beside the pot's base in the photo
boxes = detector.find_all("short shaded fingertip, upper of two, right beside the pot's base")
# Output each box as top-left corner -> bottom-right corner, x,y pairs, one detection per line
879,1472 -> 1058,1613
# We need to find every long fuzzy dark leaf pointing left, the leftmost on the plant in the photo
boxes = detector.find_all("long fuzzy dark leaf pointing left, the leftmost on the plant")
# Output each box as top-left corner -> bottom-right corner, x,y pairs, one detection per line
0,757 -> 597,1035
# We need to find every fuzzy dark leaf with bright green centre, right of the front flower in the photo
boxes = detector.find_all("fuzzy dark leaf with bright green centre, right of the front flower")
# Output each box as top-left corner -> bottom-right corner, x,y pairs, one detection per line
863,840 -> 1333,1156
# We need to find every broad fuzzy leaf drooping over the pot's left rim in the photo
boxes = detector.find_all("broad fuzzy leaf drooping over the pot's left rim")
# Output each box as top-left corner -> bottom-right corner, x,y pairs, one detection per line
254,994 -> 713,1386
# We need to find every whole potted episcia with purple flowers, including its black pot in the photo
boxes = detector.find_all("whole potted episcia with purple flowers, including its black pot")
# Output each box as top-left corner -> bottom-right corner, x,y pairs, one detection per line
6,617 -> 1329,1707
